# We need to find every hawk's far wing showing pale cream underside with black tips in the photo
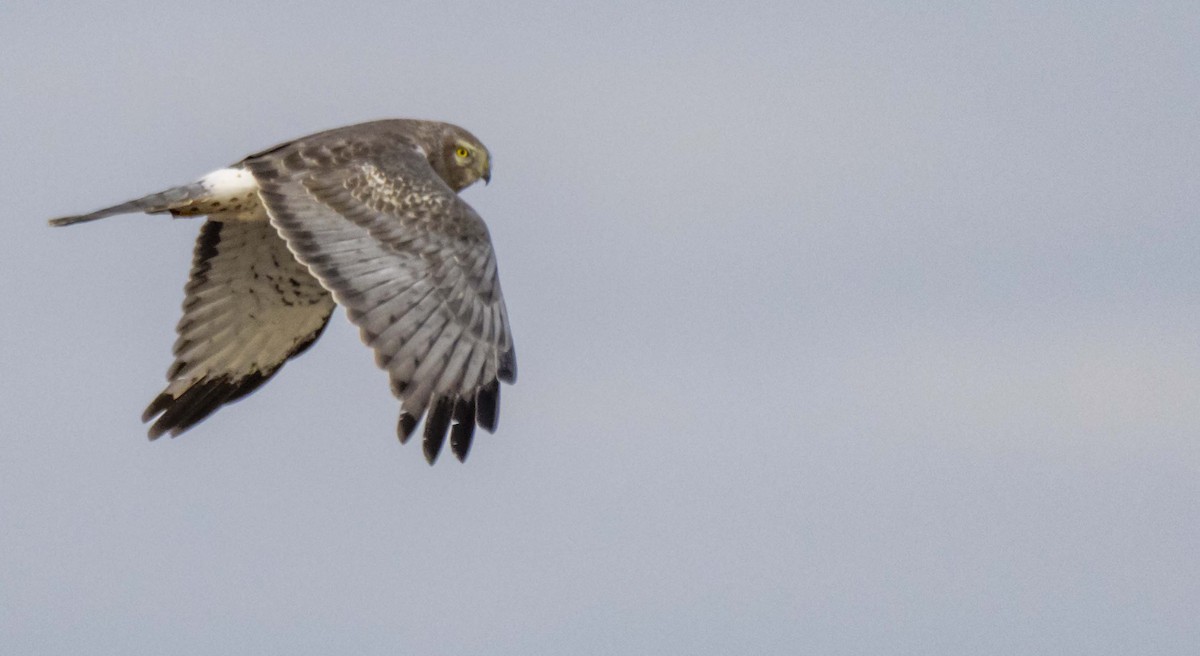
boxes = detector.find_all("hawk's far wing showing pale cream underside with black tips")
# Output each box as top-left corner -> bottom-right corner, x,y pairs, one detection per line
142,219 -> 334,439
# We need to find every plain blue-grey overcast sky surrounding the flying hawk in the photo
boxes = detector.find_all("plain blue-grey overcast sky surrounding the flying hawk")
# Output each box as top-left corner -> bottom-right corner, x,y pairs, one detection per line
0,0 -> 1200,656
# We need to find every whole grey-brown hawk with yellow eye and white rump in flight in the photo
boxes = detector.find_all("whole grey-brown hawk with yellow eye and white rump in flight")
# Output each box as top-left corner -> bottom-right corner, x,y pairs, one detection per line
50,119 -> 516,464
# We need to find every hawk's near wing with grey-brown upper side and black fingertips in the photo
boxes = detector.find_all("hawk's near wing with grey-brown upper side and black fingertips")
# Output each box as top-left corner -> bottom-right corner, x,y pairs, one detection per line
245,136 -> 516,463
